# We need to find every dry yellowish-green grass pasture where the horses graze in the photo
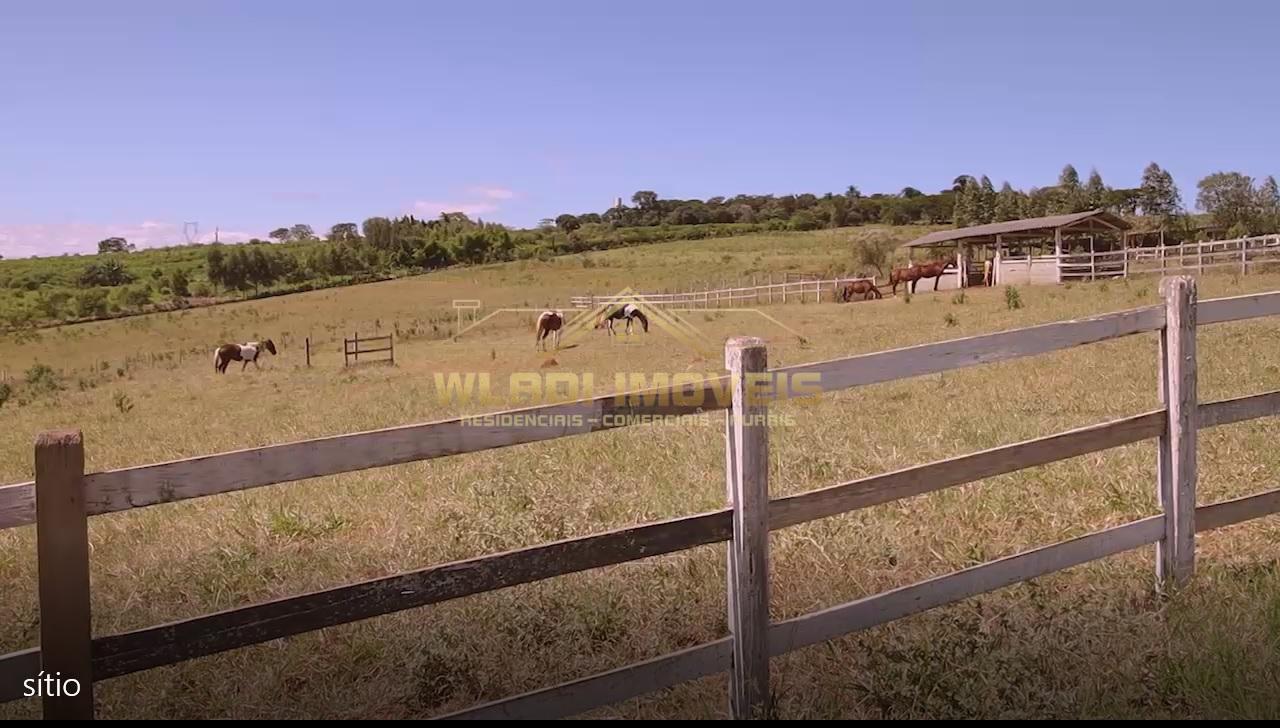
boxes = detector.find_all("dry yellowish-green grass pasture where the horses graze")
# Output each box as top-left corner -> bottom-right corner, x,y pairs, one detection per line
0,232 -> 1280,718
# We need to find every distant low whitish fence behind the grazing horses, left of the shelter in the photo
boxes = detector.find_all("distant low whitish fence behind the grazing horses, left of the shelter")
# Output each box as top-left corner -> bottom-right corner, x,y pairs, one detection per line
570,276 -> 876,308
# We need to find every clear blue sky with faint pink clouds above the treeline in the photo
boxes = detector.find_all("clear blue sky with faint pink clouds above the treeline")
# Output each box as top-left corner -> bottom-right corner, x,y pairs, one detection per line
0,0 -> 1280,257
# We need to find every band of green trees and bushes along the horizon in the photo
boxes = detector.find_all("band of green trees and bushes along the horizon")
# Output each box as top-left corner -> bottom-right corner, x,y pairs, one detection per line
0,164 -> 1280,329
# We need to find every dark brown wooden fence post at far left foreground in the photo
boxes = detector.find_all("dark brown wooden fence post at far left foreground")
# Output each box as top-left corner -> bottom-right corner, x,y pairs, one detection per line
31,430 -> 93,720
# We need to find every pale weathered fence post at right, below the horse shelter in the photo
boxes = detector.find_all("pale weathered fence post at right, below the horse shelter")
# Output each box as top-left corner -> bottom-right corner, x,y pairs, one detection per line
1156,275 -> 1199,589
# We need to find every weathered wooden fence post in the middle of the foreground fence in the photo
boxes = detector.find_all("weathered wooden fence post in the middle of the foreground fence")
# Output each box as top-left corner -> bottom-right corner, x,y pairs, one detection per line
724,336 -> 769,719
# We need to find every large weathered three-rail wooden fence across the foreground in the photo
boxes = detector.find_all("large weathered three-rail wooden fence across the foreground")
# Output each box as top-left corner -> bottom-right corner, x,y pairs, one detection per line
0,276 -> 1280,718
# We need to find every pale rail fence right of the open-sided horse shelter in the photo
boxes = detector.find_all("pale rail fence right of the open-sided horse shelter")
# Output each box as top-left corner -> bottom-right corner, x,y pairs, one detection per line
1048,235 -> 1280,281
